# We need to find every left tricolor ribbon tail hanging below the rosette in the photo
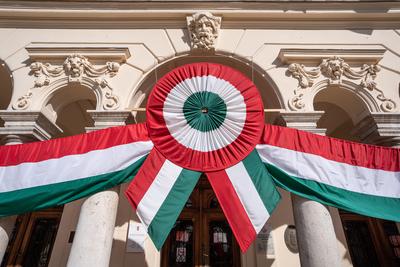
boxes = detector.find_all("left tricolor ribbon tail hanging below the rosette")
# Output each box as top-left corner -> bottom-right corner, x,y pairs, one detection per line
125,148 -> 201,250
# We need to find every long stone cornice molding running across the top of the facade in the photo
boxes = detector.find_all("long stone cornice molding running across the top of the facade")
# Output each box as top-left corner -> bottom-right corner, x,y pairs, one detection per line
0,4 -> 400,29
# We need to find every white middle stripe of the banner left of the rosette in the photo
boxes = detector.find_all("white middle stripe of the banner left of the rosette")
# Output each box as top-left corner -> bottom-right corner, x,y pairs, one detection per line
0,141 -> 153,193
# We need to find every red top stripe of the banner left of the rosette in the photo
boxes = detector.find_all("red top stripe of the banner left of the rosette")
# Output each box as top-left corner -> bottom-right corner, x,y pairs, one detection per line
0,123 -> 150,166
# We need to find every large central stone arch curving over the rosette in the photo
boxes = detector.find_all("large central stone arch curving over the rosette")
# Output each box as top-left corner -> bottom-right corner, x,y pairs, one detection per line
124,54 -> 285,120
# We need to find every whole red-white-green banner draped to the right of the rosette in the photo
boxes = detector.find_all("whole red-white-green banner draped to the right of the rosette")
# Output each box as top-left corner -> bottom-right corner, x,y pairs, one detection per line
256,125 -> 400,221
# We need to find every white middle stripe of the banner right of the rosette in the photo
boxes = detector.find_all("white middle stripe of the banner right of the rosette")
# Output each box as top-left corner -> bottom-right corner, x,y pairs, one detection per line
256,144 -> 400,198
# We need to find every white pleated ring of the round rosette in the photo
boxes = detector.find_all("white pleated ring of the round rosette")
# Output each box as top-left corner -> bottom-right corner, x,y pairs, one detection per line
163,75 -> 246,152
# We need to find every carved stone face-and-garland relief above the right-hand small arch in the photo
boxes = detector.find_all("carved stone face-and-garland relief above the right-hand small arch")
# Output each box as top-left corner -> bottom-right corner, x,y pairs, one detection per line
288,56 -> 396,112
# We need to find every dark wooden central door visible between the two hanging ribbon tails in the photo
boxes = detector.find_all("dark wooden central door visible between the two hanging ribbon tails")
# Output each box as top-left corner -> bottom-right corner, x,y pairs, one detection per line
161,177 -> 240,267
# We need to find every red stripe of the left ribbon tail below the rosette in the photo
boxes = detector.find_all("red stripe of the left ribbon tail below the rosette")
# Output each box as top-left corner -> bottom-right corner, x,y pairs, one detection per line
125,148 -> 166,210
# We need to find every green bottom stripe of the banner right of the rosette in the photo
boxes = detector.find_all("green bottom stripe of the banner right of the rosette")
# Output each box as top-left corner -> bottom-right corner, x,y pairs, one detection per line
265,164 -> 400,221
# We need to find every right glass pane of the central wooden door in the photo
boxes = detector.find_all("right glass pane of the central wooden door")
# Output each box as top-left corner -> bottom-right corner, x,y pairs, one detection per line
209,221 -> 233,267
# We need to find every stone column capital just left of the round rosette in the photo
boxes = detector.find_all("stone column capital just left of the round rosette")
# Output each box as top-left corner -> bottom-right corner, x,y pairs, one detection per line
85,110 -> 132,132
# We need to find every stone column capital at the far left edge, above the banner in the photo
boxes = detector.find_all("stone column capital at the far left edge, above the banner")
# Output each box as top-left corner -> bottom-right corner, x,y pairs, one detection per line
0,110 -> 62,141
